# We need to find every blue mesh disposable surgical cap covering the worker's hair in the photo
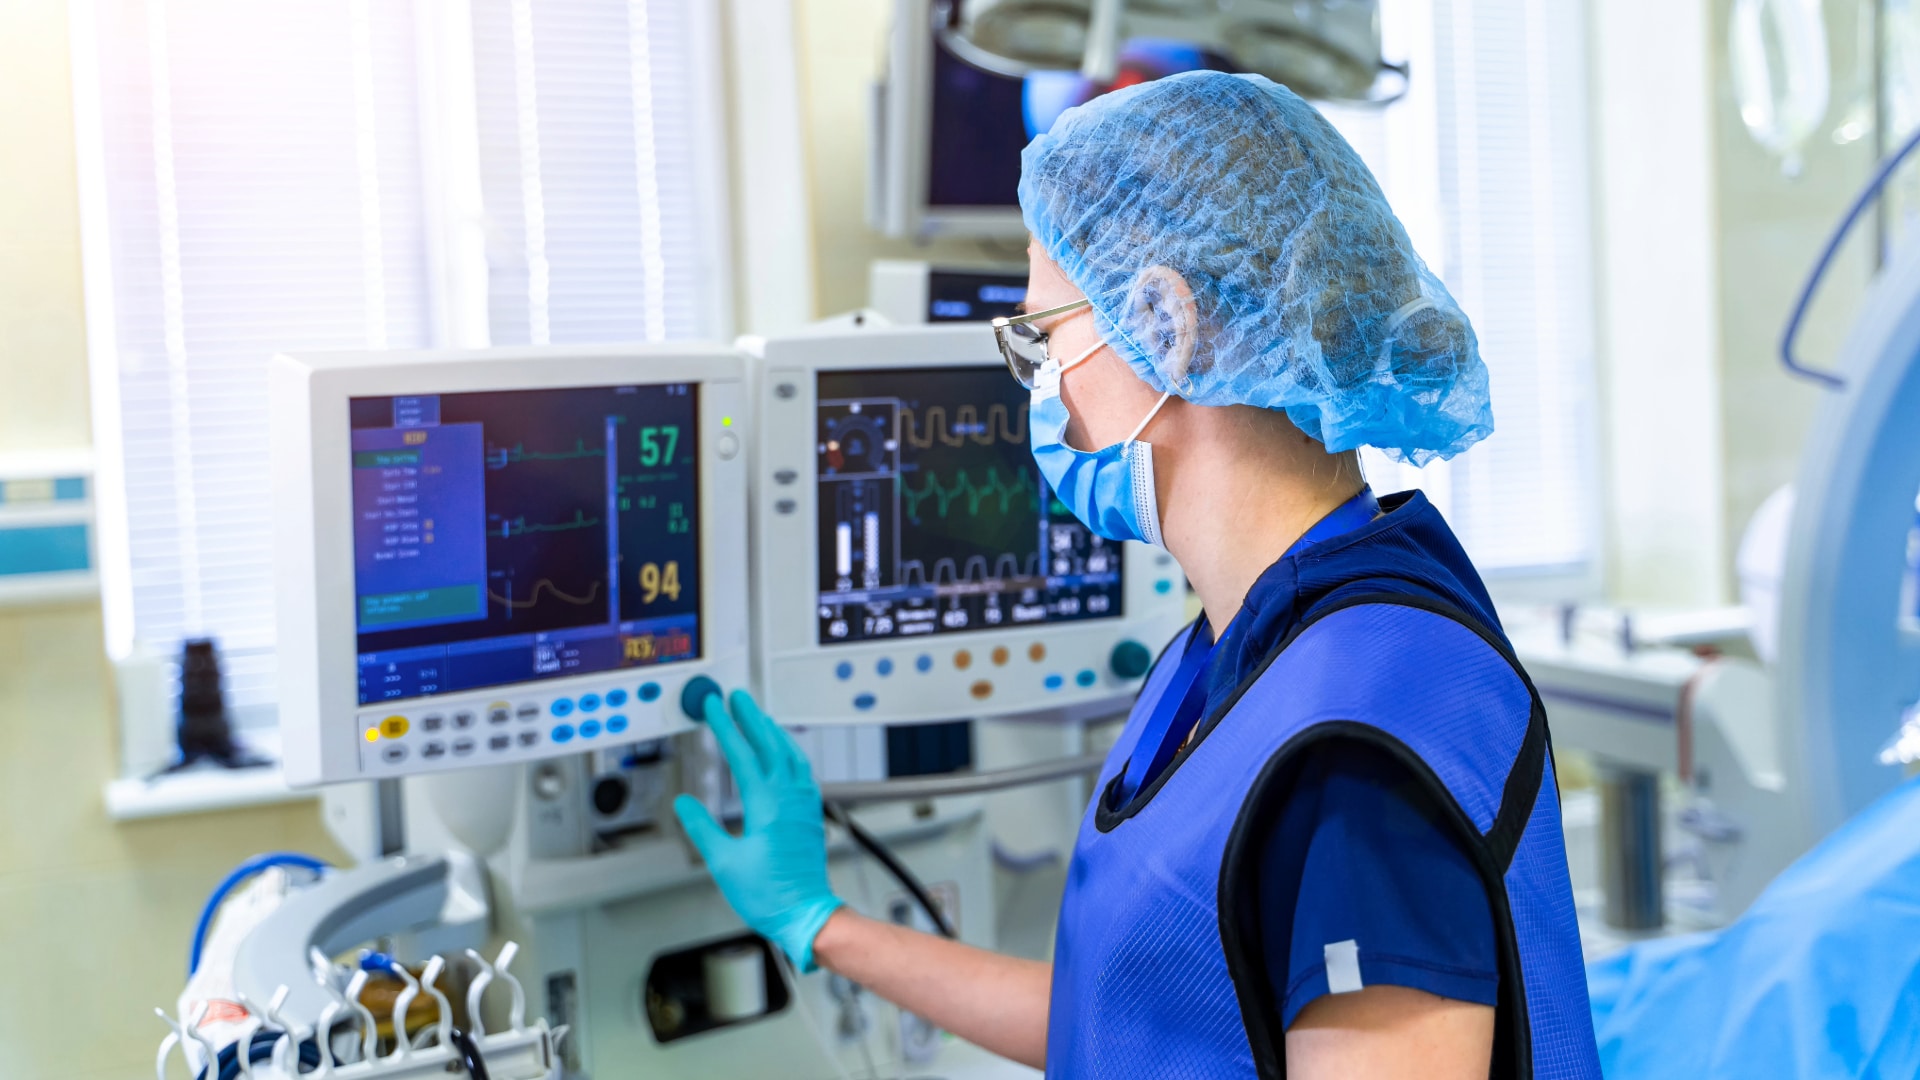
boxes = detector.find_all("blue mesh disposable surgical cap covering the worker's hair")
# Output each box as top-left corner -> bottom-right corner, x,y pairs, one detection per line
1020,71 -> 1494,465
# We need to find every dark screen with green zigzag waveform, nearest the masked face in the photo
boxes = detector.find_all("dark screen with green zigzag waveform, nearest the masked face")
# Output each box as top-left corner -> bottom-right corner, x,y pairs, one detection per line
816,367 -> 1123,644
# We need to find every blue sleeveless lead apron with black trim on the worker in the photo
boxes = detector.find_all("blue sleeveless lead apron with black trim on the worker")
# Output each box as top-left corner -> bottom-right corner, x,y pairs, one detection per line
1046,492 -> 1599,1078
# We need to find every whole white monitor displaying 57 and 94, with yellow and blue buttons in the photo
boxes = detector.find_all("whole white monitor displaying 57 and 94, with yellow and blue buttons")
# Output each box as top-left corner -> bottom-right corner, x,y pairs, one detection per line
275,346 -> 747,782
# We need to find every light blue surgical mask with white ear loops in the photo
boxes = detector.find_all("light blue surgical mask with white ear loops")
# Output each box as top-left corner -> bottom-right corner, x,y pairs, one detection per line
1027,342 -> 1173,548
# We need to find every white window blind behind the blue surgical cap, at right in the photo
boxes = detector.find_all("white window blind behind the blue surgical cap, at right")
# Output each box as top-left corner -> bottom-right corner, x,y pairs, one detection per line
1325,0 -> 1599,575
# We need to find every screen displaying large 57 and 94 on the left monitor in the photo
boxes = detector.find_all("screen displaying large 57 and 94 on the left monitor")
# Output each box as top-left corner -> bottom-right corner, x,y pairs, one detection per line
351,382 -> 701,705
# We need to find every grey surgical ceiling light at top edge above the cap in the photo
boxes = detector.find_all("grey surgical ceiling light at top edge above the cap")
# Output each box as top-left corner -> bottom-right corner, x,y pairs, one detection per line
933,0 -> 1407,102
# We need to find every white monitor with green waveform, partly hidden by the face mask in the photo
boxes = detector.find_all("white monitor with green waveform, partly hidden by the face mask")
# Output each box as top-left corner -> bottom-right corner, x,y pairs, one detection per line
745,325 -> 1185,724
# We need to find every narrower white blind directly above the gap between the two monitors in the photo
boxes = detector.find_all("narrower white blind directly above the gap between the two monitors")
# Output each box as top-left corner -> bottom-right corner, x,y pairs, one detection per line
472,0 -> 724,344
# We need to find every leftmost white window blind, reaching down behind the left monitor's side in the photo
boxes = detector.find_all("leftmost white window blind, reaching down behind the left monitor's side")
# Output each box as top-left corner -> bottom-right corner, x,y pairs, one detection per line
88,0 -> 428,709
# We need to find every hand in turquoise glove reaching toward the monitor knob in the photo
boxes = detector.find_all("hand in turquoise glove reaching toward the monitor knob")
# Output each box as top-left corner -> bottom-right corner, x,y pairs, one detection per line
674,690 -> 843,972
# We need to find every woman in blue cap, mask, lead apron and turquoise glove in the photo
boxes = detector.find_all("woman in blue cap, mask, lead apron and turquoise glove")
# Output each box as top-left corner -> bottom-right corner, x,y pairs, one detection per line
676,73 -> 1599,1078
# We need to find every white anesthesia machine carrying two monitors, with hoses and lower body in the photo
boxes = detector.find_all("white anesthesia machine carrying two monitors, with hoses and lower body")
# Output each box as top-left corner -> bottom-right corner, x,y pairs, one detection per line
163,319 -> 1185,1078
